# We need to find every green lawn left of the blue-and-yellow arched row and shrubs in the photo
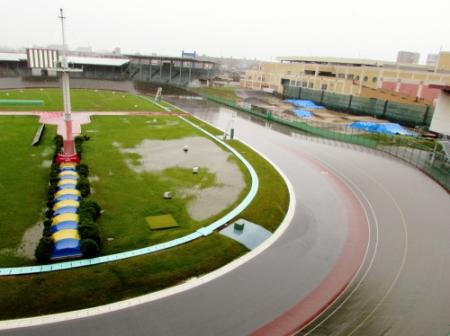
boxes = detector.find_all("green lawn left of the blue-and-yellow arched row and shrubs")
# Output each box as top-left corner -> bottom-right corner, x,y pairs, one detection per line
0,116 -> 56,266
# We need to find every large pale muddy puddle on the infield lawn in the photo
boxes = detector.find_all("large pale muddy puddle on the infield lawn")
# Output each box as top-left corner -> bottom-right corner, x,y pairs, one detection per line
121,137 -> 245,221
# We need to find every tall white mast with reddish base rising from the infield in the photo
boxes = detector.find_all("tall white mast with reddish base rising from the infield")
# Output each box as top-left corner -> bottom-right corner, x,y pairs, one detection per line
58,8 -> 76,156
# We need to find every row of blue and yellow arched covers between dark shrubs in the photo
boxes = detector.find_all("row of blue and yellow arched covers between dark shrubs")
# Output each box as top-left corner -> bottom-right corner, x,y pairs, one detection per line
50,163 -> 82,260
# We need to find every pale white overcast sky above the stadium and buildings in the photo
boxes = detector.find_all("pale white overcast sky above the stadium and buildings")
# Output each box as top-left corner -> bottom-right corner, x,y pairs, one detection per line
0,0 -> 450,62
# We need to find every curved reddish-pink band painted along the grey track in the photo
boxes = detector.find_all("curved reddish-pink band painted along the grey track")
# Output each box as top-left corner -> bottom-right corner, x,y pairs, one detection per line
252,147 -> 369,336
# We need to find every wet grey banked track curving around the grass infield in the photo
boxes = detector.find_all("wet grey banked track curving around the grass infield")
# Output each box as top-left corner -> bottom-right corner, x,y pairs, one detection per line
0,103 -> 450,335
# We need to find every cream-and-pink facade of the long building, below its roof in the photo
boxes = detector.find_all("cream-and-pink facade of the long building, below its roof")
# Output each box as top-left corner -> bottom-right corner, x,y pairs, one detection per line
241,57 -> 450,103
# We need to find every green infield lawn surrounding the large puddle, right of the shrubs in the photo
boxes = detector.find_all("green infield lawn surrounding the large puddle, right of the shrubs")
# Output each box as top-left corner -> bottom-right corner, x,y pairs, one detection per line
83,116 -> 249,254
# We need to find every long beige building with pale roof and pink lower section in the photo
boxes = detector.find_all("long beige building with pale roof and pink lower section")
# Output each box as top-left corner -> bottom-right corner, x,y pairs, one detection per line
241,52 -> 450,103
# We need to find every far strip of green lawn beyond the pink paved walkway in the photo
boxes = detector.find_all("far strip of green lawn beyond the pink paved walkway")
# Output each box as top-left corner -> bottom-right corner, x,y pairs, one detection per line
0,88 -> 164,112
